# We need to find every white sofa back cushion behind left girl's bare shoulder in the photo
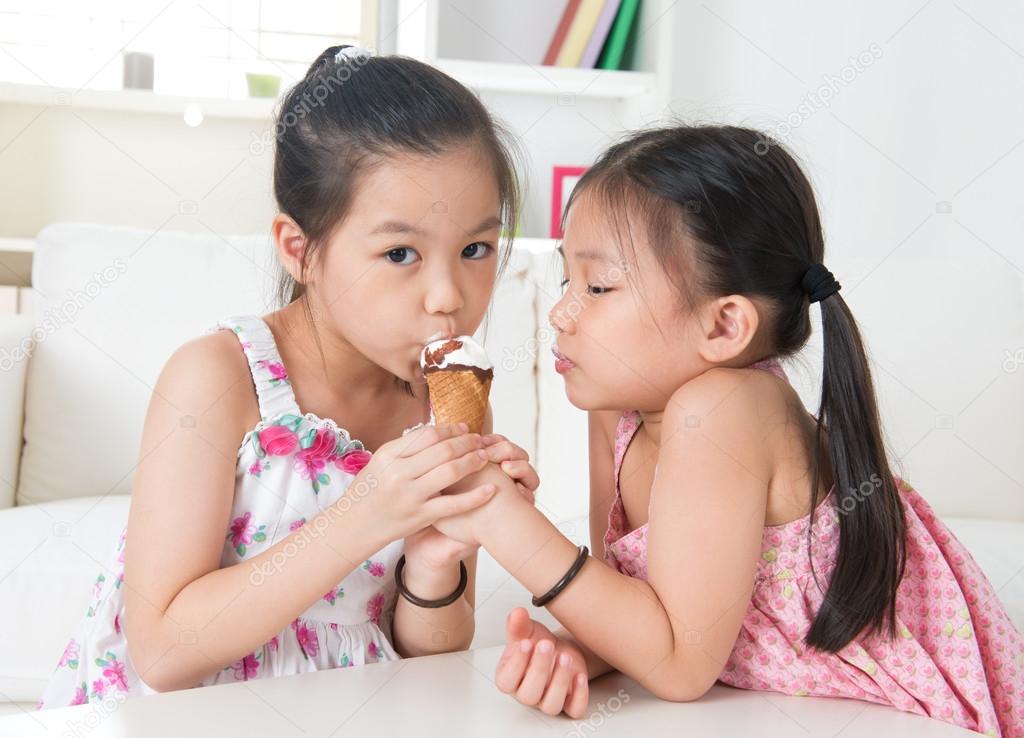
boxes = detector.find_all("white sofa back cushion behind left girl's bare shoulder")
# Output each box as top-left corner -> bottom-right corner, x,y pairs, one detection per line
17,224 -> 274,505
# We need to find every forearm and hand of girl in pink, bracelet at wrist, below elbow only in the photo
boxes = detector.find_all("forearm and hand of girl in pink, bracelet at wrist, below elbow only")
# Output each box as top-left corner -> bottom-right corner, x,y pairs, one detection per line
476,468 -> 707,700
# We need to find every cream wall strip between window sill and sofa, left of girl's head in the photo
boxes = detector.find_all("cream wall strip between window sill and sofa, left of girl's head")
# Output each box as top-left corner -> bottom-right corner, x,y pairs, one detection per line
0,101 -> 273,237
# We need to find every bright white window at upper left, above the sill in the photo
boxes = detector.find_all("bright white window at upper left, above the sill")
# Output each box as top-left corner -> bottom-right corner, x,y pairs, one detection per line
0,0 -> 368,98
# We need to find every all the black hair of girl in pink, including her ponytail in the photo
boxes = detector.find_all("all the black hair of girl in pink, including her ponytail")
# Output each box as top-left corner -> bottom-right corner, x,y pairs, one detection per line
566,126 -> 905,653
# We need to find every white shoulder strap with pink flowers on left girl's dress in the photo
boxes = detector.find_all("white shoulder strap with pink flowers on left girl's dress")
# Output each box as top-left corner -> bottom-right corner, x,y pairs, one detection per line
206,315 -> 302,421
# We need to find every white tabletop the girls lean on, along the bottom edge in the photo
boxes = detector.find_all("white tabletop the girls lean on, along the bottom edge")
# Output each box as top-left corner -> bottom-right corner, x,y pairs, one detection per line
0,647 -> 977,738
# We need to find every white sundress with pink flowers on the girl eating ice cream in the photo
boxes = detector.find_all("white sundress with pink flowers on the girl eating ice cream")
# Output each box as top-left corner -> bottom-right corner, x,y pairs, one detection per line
37,315 -> 403,709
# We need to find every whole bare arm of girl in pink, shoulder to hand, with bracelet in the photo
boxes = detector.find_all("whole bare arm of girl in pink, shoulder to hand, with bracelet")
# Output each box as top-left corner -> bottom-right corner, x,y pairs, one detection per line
460,370 -> 771,700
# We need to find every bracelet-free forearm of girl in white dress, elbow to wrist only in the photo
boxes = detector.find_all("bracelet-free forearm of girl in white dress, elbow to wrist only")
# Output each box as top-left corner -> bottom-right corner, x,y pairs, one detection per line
125,501 -> 387,692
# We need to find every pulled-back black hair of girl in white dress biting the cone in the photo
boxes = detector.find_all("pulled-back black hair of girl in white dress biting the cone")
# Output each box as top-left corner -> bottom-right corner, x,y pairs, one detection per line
273,45 -> 520,305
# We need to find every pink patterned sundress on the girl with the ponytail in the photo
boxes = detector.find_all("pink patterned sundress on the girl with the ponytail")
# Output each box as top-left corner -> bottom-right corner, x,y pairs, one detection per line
604,358 -> 1024,738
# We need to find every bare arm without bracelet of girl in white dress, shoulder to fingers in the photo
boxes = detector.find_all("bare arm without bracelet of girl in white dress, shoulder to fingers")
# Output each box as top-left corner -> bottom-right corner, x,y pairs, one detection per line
125,334 -> 490,690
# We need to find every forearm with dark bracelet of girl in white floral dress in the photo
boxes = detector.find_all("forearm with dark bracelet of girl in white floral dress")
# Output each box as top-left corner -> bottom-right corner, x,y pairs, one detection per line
393,561 -> 476,657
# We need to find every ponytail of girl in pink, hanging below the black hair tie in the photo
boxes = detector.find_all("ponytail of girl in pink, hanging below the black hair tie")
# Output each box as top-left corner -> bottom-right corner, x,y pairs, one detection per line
805,295 -> 906,653
